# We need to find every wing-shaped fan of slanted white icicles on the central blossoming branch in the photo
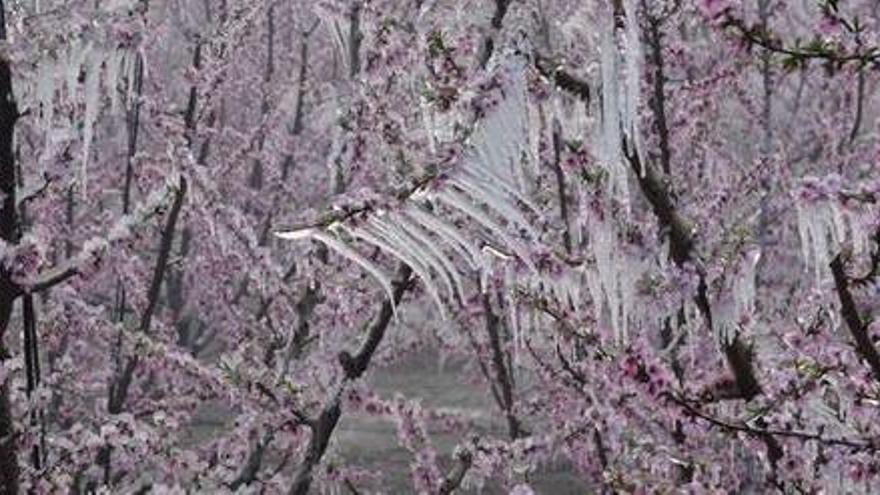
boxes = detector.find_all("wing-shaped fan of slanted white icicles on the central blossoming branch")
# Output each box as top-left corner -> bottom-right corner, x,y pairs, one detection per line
278,57 -> 540,318
